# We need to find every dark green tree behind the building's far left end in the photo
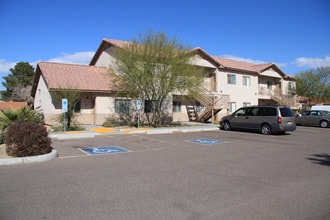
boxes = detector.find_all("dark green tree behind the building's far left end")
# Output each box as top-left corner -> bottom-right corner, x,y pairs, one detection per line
1,62 -> 34,101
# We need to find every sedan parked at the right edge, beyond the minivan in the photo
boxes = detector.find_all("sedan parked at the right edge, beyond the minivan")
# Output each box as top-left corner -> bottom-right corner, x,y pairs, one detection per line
296,110 -> 330,128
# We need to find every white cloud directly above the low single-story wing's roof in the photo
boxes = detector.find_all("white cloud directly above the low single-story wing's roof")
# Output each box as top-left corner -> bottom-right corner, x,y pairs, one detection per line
48,51 -> 94,64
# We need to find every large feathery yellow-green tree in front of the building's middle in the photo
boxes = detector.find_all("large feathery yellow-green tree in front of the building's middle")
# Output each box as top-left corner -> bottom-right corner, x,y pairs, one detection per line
112,30 -> 202,126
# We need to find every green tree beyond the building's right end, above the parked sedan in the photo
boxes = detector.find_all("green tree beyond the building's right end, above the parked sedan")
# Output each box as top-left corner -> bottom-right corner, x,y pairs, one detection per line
296,66 -> 330,105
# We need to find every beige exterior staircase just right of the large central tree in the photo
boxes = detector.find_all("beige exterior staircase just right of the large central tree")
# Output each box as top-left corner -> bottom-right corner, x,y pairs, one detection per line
186,87 -> 229,122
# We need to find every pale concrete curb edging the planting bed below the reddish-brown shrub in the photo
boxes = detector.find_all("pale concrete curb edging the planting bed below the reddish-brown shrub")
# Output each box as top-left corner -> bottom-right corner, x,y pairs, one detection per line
0,149 -> 57,165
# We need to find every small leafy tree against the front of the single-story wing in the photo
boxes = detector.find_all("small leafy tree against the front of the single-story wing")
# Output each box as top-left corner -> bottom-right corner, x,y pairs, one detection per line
52,89 -> 80,130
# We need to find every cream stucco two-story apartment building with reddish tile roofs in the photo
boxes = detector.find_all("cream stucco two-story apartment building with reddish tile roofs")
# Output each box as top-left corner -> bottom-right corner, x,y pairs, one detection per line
32,39 -> 295,125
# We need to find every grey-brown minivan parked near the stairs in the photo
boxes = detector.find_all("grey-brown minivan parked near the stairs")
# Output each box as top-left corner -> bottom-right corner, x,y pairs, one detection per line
220,106 -> 296,135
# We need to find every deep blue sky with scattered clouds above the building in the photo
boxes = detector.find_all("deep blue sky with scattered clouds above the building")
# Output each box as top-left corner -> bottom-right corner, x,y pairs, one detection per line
0,0 -> 330,89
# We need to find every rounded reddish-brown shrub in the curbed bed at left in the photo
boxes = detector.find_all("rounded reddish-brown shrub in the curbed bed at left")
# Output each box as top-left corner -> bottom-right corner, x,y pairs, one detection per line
5,122 -> 51,157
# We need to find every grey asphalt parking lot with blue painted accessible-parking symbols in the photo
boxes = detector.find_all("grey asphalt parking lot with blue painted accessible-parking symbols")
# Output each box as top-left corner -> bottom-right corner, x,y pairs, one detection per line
0,127 -> 330,219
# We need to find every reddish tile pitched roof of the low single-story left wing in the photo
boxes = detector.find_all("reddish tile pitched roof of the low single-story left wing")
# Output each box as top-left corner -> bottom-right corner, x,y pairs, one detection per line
32,62 -> 114,94
